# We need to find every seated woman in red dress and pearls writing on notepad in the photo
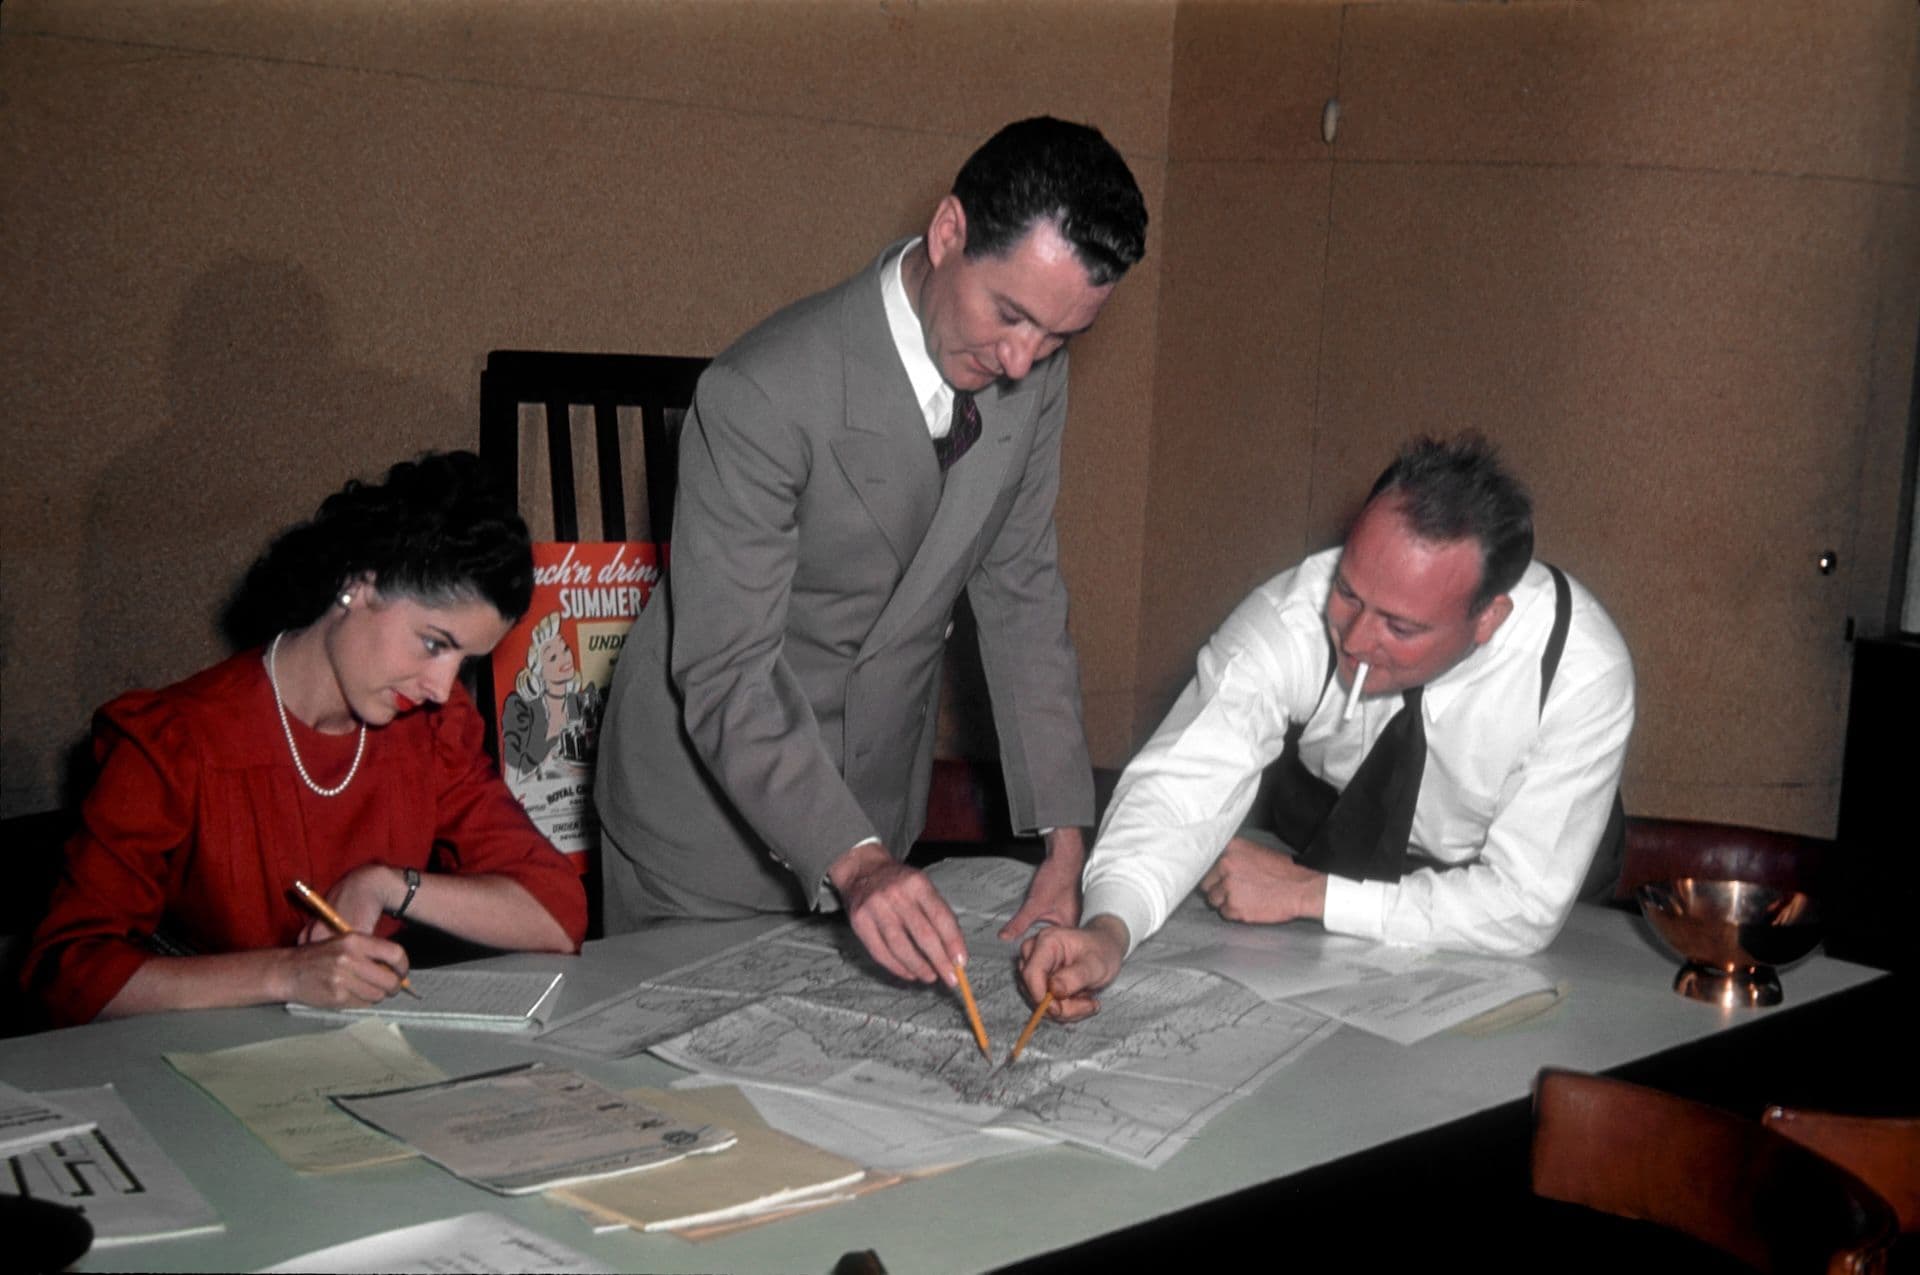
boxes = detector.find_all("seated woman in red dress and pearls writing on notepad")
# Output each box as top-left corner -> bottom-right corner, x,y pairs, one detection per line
25,453 -> 586,1023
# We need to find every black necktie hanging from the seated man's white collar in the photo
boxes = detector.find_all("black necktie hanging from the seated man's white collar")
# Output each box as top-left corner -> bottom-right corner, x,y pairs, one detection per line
1298,686 -> 1427,881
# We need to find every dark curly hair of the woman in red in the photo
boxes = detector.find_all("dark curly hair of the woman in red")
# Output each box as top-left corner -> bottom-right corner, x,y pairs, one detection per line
221,451 -> 534,649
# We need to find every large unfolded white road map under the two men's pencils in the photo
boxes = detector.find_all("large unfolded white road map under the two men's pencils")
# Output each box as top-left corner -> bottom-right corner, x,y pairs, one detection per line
541,860 -> 1336,1166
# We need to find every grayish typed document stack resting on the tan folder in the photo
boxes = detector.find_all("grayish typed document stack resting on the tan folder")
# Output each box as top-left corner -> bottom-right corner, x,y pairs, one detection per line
334,1062 -> 733,1194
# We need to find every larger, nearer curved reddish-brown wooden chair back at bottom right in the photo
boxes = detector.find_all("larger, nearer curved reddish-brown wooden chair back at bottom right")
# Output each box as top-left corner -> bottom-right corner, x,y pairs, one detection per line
1532,1070 -> 1897,1273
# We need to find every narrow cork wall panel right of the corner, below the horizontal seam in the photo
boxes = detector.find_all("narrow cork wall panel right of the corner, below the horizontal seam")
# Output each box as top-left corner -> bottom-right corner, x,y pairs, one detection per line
1137,163 -> 1329,737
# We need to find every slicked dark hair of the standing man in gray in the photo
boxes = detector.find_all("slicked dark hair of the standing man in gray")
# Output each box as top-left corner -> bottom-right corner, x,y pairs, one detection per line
952,115 -> 1146,288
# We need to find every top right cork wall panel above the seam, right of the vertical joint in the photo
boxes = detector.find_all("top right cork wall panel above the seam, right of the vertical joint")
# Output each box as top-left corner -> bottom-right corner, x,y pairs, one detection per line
1340,0 -> 1916,180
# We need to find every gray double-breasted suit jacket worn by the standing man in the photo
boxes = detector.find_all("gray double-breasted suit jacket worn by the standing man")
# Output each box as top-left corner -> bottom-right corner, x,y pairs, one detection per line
595,250 -> 1092,933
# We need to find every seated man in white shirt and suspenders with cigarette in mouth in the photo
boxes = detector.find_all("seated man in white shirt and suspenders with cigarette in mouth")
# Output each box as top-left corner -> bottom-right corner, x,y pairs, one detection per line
1021,443 -> 1634,1018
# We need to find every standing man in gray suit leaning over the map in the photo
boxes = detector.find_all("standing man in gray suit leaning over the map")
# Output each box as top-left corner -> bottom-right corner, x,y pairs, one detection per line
593,117 -> 1146,981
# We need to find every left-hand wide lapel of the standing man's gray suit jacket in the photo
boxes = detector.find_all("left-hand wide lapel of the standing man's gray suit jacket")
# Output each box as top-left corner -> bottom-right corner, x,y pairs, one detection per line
831,248 -> 941,568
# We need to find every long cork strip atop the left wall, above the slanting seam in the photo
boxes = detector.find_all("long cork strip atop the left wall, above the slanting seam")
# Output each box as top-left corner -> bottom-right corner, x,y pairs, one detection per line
6,0 -> 1175,152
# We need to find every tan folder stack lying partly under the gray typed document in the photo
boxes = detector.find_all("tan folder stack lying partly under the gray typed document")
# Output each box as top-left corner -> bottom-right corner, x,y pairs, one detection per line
551,1085 -> 866,1231
